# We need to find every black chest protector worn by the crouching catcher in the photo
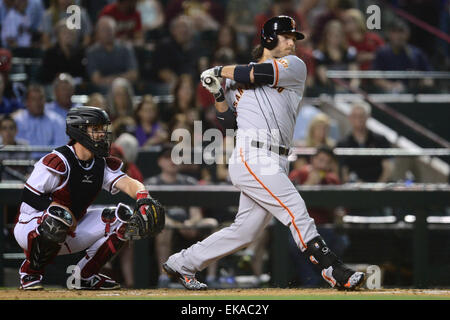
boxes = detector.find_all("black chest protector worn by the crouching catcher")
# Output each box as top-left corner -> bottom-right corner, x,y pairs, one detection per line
51,146 -> 105,220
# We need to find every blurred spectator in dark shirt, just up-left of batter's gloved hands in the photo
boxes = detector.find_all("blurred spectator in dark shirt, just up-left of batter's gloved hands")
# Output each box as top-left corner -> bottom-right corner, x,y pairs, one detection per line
153,15 -> 199,88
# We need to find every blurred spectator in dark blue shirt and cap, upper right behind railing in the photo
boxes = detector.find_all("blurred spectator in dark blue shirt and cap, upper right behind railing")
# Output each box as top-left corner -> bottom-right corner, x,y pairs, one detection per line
372,19 -> 433,93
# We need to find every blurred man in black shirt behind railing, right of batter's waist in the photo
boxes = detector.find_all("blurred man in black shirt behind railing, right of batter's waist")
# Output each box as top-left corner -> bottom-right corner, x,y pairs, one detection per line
337,101 -> 393,182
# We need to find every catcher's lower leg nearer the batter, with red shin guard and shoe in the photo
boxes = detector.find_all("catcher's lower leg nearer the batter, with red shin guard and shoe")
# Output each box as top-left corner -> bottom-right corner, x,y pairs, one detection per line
71,203 -> 133,290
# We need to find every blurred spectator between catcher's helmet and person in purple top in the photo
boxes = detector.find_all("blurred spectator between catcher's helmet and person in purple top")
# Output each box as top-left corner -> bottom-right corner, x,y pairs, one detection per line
108,78 -> 136,137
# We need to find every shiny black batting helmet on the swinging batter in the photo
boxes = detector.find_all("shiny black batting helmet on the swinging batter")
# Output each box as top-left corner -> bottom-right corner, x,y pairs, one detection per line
261,16 -> 305,50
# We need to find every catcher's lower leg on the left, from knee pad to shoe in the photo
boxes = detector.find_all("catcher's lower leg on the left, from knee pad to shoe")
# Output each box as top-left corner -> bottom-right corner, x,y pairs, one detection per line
19,206 -> 73,290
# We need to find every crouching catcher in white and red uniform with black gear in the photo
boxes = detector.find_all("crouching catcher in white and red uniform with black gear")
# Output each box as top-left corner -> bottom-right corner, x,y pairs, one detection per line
14,107 -> 165,290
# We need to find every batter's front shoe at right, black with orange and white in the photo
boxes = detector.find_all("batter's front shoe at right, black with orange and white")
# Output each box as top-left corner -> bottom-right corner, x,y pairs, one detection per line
322,265 -> 365,291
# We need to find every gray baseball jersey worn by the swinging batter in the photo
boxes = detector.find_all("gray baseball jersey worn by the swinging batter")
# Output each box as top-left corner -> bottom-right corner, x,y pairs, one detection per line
225,55 -> 306,147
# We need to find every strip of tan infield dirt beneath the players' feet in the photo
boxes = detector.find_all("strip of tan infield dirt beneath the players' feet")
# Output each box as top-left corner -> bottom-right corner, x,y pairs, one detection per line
0,288 -> 450,300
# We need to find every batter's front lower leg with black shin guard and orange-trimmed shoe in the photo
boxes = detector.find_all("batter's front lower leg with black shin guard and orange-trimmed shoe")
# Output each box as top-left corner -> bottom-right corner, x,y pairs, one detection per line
305,236 -> 365,290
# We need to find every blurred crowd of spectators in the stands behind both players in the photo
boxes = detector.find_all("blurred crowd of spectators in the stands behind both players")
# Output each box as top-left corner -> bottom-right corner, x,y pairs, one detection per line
0,0 -> 450,287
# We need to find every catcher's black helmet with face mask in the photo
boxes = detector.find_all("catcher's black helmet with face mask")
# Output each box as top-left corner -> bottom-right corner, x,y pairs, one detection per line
66,106 -> 111,157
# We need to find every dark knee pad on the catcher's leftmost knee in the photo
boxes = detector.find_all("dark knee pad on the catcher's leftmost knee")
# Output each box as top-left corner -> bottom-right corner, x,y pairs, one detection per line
37,206 -> 73,243
